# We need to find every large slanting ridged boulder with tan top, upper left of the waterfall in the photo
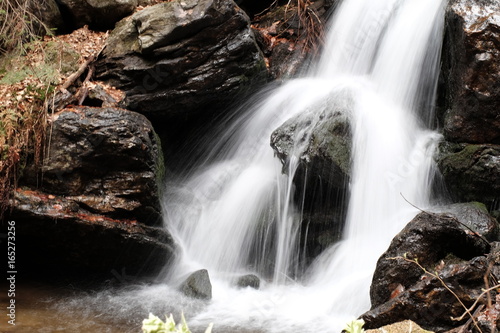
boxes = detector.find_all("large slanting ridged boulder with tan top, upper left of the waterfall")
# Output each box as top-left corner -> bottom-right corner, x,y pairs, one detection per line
96,0 -> 267,121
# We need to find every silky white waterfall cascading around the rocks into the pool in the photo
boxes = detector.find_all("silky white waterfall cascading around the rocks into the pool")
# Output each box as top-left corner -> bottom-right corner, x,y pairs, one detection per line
10,0 -> 446,332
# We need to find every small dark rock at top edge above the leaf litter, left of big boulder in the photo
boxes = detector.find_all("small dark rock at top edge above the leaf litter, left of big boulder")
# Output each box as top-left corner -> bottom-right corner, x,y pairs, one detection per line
58,0 -> 139,30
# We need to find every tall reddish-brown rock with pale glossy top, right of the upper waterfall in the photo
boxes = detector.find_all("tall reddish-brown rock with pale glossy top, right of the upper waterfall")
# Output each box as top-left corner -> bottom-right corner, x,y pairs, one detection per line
441,0 -> 500,144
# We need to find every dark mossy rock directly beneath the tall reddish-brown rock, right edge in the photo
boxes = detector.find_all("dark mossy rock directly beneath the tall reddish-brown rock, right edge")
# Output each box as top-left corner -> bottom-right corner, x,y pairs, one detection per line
436,142 -> 500,207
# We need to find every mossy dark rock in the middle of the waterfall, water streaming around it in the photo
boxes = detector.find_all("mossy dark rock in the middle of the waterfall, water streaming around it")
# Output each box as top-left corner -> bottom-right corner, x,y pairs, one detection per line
271,94 -> 351,257
